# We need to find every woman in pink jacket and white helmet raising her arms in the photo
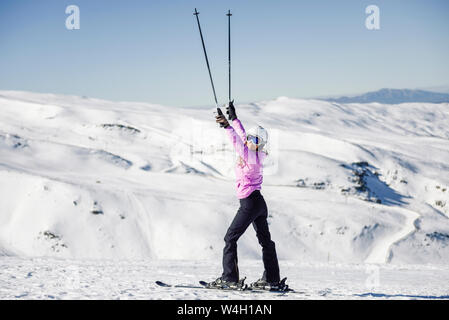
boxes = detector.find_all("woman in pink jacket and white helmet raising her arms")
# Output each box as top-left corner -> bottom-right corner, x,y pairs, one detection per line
208,102 -> 280,289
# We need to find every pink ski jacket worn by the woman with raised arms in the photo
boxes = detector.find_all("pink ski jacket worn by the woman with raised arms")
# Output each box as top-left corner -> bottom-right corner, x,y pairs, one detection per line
225,119 -> 266,199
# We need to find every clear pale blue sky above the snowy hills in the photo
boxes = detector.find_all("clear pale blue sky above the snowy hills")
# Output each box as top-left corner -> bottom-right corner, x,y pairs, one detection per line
0,0 -> 449,106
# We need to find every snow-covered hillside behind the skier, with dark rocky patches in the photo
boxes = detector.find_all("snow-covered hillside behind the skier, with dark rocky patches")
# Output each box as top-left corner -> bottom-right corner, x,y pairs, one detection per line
0,91 -> 449,264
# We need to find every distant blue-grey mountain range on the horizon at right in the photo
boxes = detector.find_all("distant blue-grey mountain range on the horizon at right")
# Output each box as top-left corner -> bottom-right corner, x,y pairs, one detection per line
321,89 -> 449,104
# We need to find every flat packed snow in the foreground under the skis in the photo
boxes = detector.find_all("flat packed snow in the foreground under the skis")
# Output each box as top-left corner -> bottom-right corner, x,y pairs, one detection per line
0,257 -> 449,300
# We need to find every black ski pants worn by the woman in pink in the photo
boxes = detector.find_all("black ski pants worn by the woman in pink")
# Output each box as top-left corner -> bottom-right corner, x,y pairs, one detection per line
222,190 -> 280,282
